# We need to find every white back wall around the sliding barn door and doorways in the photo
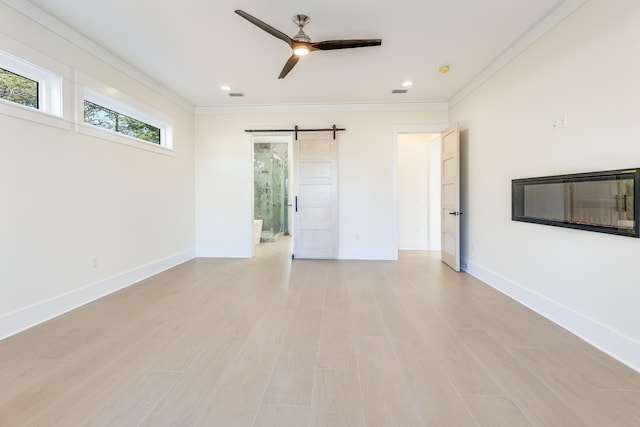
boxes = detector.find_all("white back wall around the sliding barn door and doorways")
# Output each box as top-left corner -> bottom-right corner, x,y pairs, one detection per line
196,108 -> 448,259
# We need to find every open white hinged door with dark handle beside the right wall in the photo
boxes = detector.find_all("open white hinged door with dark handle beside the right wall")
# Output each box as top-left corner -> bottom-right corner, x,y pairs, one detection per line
441,126 -> 461,271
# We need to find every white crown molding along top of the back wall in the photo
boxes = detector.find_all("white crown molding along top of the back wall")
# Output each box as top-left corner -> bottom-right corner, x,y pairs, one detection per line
195,102 -> 449,115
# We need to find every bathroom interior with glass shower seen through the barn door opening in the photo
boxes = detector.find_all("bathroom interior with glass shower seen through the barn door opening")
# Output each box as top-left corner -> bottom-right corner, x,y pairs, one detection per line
253,142 -> 291,245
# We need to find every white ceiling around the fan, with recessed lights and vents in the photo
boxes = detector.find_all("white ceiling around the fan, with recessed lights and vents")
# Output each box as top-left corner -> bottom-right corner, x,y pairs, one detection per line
23,0 -> 564,107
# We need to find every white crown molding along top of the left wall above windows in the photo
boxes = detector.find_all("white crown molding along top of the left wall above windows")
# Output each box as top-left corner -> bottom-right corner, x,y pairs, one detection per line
0,0 -> 194,113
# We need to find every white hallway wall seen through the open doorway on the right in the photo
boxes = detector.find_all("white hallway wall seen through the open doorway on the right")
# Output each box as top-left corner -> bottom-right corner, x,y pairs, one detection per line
398,134 -> 430,250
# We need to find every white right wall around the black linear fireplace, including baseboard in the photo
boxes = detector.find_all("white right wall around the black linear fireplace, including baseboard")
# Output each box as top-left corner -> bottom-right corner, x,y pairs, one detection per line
451,0 -> 640,369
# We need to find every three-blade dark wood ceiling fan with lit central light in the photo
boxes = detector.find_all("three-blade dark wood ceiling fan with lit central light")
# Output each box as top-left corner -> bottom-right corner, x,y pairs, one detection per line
235,10 -> 382,79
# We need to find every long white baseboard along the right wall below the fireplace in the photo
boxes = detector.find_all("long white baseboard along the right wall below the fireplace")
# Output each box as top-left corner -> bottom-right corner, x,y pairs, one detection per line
462,259 -> 640,372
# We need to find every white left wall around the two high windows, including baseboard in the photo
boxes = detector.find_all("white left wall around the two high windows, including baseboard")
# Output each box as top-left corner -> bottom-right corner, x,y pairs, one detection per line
0,3 -> 195,338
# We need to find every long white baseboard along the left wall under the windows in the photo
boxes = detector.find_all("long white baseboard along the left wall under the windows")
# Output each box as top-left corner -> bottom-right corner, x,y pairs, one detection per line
0,249 -> 195,339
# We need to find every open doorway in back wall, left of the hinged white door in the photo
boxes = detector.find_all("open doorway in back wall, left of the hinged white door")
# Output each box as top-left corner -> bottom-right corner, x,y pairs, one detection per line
397,133 -> 441,251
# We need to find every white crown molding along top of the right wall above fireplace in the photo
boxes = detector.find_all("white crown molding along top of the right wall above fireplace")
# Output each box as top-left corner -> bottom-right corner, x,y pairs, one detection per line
448,0 -> 588,108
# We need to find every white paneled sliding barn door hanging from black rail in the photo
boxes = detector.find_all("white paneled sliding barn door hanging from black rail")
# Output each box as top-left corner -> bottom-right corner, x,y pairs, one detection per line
293,132 -> 338,259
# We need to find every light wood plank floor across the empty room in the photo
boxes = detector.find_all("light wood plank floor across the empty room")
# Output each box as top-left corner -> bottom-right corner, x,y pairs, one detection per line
0,239 -> 640,427
